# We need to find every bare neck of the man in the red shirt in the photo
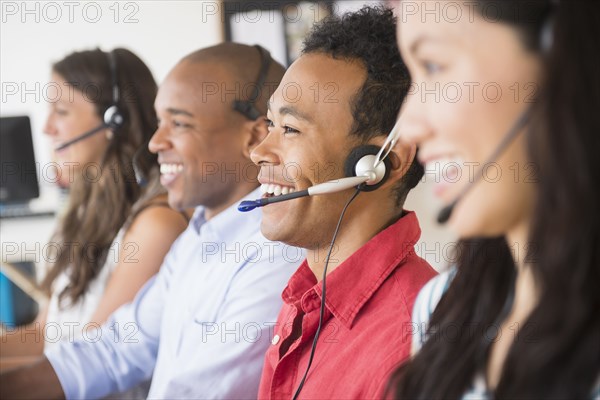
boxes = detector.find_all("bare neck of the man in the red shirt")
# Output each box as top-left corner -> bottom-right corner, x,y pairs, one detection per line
306,203 -> 402,281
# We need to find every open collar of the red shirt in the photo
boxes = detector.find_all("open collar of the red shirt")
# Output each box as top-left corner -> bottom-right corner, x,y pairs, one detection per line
282,211 -> 421,329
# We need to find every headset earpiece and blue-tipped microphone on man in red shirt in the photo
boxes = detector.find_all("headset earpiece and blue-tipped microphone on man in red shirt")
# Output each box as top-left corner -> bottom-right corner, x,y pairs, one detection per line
238,145 -> 391,212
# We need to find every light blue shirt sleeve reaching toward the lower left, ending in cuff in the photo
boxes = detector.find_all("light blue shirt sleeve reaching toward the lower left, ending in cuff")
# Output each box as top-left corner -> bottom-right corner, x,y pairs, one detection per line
45,247 -> 175,399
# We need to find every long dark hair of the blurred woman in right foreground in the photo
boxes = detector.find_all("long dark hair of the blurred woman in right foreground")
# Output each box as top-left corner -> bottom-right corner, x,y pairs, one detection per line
390,0 -> 600,399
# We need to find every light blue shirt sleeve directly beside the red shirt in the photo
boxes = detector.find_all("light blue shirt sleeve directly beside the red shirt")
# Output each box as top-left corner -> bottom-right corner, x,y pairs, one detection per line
166,249 -> 297,399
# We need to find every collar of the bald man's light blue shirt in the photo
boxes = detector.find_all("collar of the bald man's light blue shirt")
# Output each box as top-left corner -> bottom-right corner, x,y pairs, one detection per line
191,188 -> 262,240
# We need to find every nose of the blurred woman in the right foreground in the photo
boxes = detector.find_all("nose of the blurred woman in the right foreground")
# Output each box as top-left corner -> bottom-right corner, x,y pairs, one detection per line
398,93 -> 432,145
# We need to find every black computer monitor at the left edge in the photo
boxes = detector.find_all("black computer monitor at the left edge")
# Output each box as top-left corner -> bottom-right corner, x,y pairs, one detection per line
0,116 -> 40,204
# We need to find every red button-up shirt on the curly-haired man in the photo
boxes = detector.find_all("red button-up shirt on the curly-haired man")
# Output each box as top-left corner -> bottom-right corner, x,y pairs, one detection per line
258,212 -> 436,400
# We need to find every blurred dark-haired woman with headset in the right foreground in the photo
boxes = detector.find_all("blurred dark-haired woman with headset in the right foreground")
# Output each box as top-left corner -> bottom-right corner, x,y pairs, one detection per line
390,0 -> 600,399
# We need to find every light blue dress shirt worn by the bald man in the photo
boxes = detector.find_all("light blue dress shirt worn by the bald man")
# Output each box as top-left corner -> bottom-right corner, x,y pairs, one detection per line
46,191 -> 304,399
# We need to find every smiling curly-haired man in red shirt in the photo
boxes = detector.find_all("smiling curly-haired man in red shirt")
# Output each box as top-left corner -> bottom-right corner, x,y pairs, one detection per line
252,7 -> 435,399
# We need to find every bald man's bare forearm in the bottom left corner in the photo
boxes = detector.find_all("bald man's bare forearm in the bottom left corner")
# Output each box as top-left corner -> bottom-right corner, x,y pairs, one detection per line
0,357 -> 65,400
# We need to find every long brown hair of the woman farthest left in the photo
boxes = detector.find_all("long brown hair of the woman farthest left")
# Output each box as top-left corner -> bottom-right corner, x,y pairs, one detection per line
42,49 -> 160,304
